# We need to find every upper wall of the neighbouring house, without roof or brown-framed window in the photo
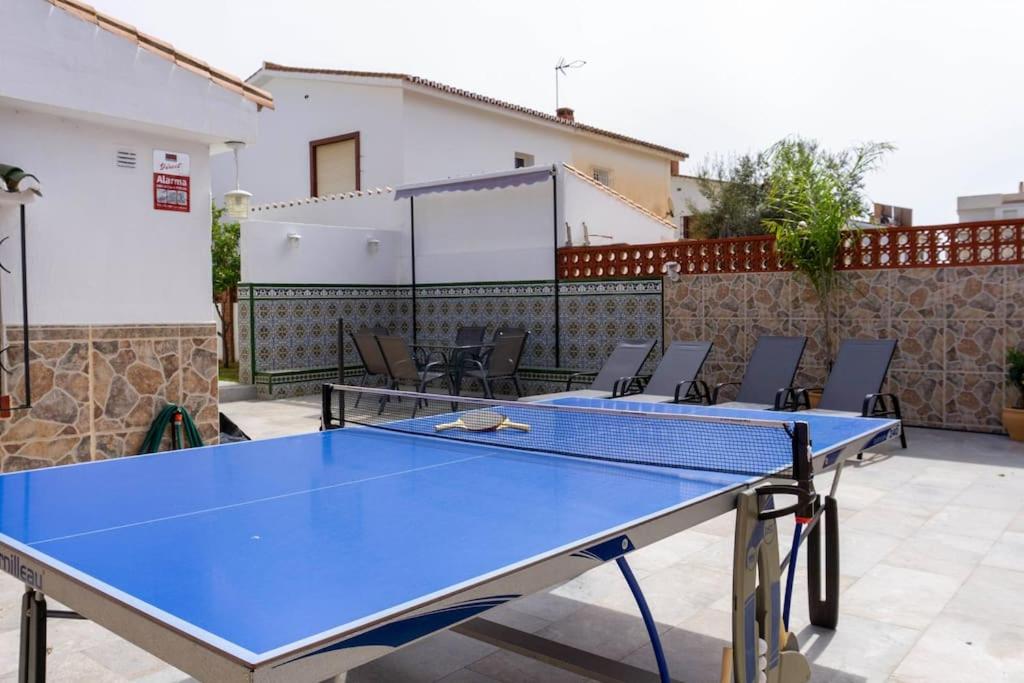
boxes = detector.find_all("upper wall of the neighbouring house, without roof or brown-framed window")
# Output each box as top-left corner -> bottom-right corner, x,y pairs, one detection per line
213,72 -> 669,215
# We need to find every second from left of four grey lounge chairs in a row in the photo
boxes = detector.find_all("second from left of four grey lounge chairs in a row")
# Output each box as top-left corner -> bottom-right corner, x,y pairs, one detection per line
612,341 -> 712,403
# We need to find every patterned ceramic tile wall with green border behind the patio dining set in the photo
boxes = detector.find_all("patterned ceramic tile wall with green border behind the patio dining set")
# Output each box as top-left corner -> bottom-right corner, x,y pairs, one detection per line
239,280 -> 663,397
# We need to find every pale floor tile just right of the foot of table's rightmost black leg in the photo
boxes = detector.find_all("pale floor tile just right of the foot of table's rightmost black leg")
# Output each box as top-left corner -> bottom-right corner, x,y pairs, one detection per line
843,564 -> 961,630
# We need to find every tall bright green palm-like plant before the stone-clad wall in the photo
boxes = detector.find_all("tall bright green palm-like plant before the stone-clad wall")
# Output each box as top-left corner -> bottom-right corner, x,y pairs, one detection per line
764,138 -> 895,362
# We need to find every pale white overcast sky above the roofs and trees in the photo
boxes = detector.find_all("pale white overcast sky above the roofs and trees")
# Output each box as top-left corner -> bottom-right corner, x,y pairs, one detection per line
91,0 -> 1024,224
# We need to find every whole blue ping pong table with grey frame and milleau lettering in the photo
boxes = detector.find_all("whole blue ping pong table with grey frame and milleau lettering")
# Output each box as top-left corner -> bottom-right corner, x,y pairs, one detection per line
0,386 -> 900,681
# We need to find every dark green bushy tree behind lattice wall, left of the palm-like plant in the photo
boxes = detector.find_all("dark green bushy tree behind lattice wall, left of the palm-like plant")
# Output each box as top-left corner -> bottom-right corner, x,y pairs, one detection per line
687,153 -> 770,240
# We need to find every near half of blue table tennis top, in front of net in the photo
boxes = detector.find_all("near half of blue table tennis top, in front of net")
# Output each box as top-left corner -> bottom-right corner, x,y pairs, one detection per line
0,428 -> 744,657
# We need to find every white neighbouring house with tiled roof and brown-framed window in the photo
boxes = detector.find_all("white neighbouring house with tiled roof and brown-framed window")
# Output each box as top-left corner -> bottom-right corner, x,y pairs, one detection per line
214,62 -> 686,217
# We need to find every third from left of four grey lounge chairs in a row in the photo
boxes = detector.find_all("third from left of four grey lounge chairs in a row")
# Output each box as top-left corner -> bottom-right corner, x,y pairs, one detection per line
711,335 -> 807,410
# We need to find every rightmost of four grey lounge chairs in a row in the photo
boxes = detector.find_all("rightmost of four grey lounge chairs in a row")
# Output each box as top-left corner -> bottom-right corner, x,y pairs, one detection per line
776,339 -> 906,458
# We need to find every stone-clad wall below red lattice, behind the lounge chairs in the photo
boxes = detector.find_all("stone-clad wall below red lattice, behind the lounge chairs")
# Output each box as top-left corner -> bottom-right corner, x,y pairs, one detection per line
665,265 -> 1024,431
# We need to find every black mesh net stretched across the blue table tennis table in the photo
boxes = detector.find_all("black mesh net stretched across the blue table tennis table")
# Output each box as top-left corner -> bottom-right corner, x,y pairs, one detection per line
324,385 -> 795,476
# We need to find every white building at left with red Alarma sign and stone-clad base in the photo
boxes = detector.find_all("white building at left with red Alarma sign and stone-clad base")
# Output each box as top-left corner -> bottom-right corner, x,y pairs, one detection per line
0,0 -> 272,471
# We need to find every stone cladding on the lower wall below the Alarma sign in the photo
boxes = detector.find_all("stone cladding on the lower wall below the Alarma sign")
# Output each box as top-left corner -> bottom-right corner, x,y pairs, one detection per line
0,325 -> 219,472
